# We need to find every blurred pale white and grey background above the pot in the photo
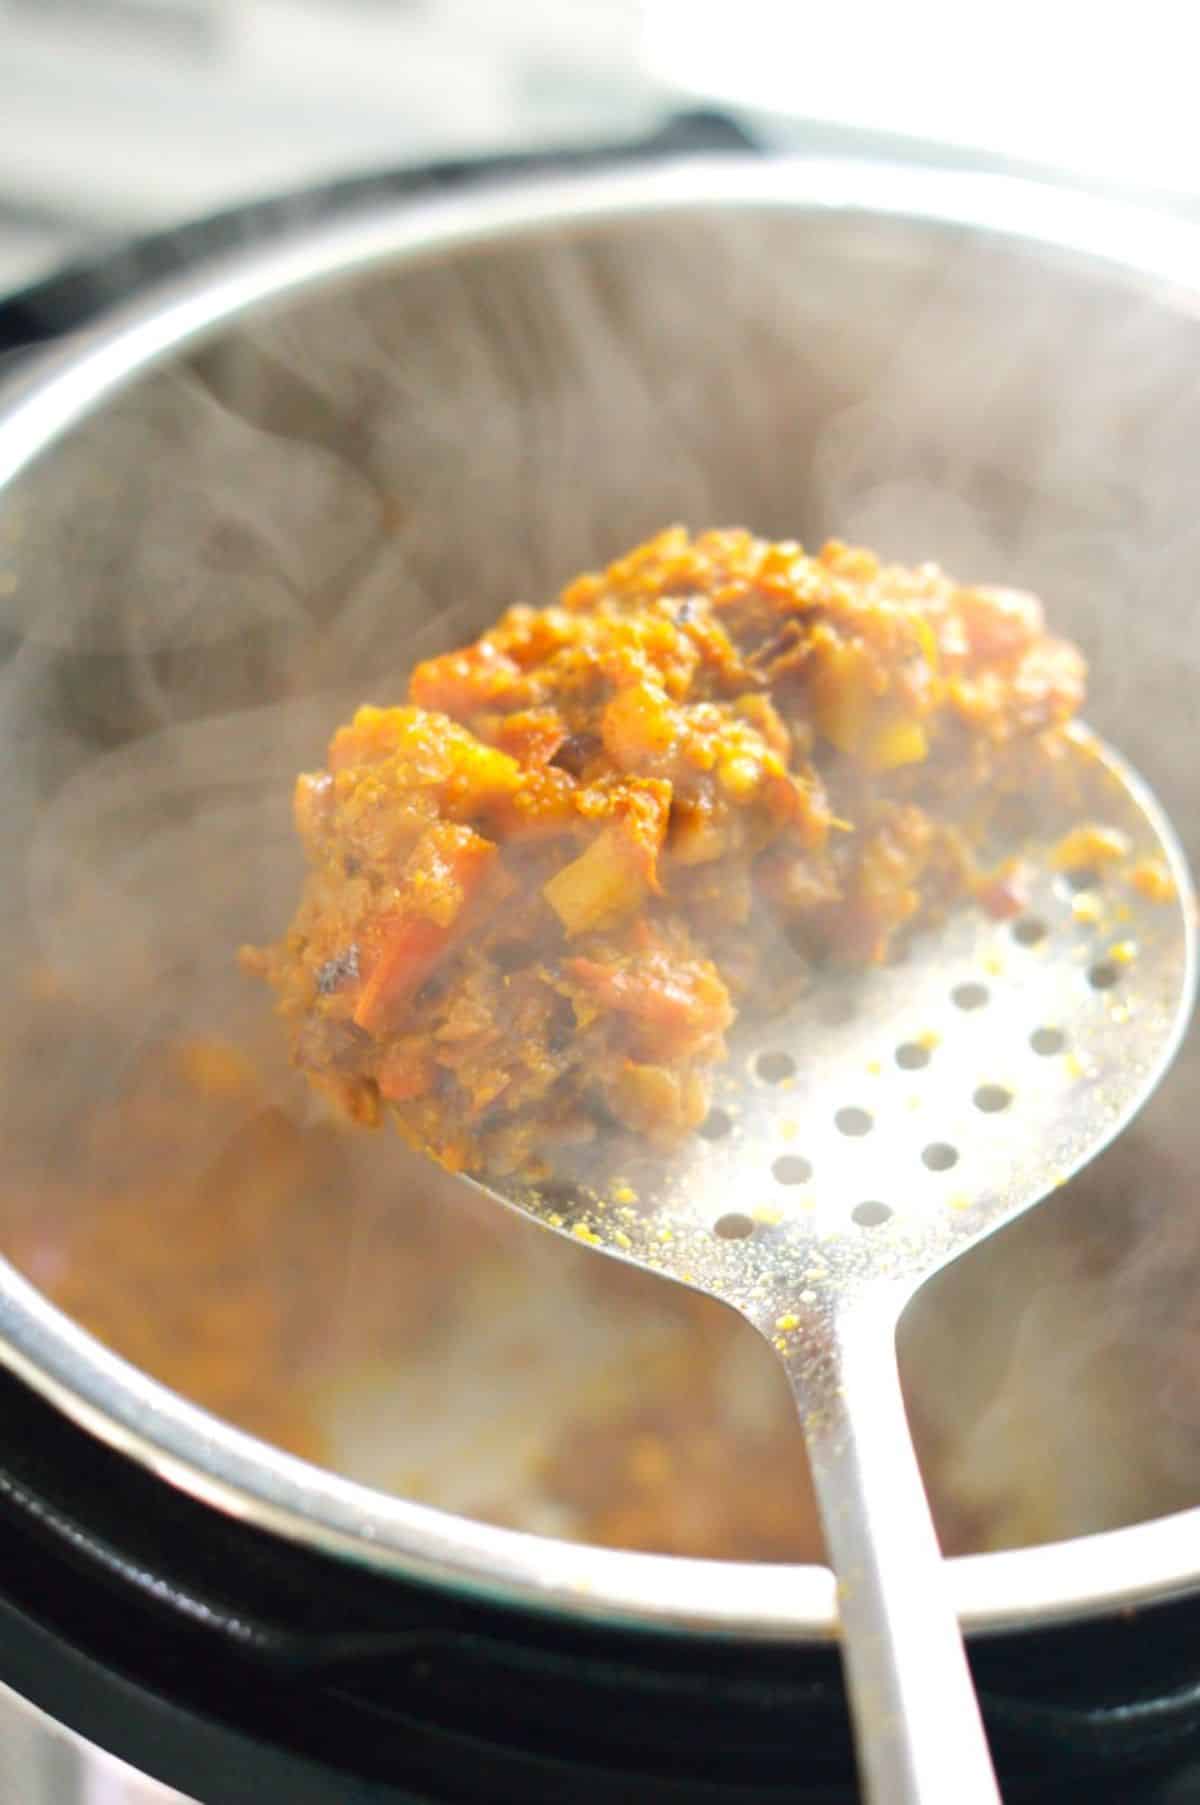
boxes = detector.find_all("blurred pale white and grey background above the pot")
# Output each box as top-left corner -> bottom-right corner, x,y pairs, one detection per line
0,0 -> 1200,291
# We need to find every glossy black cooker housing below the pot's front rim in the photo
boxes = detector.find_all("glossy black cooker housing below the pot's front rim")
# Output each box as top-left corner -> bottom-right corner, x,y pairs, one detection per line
0,1377 -> 1200,1805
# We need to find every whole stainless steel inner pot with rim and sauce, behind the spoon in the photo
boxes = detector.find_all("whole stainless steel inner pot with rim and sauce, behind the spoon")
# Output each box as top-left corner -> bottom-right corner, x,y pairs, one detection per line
0,162 -> 1200,1667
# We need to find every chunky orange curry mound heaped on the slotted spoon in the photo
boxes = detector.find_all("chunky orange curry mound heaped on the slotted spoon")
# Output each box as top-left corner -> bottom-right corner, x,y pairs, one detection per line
245,527 -> 1085,1171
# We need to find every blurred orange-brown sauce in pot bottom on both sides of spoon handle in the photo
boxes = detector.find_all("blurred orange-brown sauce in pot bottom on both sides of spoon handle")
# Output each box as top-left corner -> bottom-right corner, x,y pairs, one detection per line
0,975 -> 1195,1561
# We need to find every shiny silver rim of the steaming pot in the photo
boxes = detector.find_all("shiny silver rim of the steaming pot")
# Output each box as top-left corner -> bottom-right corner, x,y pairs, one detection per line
0,155 -> 1200,1641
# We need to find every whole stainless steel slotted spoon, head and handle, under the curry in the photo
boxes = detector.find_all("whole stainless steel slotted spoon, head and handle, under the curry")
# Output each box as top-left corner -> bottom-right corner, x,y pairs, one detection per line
464,729 -> 1195,1805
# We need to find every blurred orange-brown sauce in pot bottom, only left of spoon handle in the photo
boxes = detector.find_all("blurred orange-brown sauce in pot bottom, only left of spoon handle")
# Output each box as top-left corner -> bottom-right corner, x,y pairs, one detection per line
0,982 -> 819,1560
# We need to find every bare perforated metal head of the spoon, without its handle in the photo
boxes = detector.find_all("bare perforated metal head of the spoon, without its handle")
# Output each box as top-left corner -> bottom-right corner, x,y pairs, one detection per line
465,729 -> 1196,1338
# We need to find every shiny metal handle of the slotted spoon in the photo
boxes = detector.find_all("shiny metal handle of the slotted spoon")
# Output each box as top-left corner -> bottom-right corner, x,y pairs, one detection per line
783,1292 -> 1000,1805
